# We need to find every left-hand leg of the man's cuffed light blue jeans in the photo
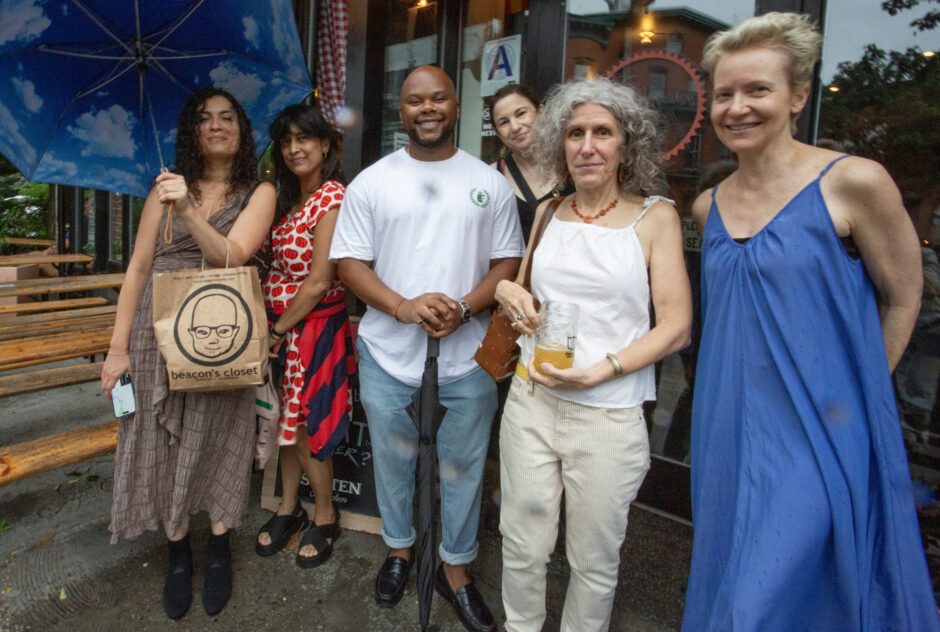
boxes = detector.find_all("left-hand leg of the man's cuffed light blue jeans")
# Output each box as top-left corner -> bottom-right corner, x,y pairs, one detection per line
358,342 -> 418,549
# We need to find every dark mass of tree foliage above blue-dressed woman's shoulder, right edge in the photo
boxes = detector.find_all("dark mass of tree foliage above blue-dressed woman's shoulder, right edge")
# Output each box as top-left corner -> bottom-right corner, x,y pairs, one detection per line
819,45 -> 940,208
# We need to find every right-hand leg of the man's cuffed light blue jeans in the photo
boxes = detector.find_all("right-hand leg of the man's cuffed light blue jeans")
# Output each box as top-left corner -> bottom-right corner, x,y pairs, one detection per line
437,371 -> 497,564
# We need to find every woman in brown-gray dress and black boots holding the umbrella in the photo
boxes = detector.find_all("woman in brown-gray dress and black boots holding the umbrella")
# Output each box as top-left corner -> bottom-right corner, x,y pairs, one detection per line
101,88 -> 275,619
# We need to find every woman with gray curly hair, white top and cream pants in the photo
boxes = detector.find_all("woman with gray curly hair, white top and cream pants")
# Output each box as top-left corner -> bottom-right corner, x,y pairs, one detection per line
496,79 -> 692,632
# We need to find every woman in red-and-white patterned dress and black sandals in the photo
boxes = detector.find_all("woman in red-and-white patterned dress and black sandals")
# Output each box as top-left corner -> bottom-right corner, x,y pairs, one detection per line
255,105 -> 355,568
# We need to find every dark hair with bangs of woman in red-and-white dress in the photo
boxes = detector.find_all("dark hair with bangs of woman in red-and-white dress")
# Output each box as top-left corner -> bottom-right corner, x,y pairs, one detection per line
268,103 -> 346,224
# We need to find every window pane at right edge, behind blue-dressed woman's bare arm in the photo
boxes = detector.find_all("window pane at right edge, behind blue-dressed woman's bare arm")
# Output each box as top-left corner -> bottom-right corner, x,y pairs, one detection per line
817,0 -> 940,586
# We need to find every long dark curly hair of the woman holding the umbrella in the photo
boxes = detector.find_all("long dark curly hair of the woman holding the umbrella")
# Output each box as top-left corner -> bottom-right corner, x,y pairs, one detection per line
176,88 -> 258,204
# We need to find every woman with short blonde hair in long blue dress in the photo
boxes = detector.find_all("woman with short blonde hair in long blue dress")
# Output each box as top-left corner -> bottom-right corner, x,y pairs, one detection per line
683,13 -> 940,632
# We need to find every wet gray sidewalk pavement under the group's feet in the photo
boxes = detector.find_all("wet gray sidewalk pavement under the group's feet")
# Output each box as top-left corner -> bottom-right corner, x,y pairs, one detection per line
0,368 -> 692,632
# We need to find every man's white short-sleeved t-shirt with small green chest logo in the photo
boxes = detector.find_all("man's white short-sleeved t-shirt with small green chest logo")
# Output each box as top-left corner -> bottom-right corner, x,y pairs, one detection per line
330,149 -> 524,386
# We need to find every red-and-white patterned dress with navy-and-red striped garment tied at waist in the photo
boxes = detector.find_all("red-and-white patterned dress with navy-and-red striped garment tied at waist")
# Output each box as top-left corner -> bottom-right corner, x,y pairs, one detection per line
264,180 -> 356,461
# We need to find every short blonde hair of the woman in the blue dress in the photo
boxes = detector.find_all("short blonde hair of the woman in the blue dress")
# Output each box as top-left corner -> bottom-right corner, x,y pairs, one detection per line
702,11 -> 822,91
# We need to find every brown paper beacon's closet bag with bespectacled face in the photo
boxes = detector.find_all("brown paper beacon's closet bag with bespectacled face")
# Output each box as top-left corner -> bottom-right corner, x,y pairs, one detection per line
153,252 -> 268,391
